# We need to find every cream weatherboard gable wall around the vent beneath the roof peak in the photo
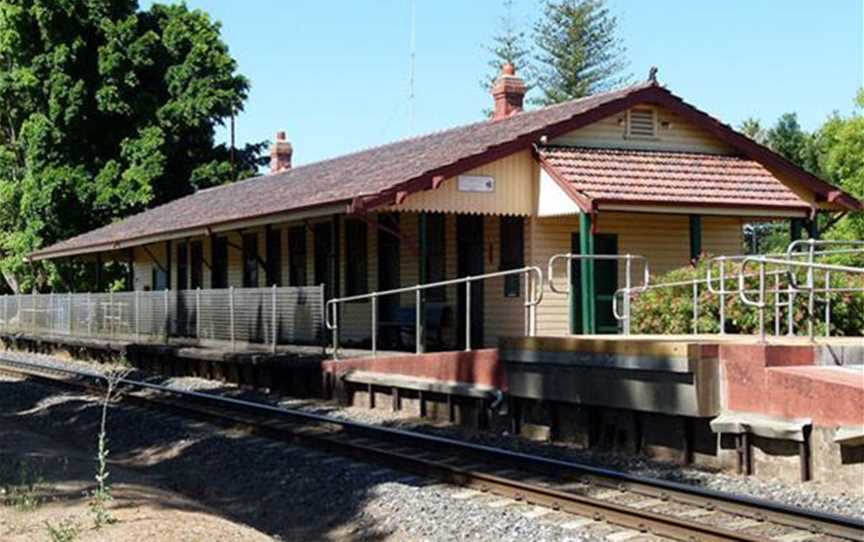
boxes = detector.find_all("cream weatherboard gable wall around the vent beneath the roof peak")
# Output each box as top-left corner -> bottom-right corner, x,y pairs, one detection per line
551,106 -> 733,154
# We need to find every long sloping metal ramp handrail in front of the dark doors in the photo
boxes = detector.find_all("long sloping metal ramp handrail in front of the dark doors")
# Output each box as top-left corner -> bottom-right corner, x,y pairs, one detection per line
324,266 -> 543,359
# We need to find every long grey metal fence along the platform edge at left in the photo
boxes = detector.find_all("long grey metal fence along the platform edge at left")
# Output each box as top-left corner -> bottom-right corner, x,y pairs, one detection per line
0,286 -> 324,349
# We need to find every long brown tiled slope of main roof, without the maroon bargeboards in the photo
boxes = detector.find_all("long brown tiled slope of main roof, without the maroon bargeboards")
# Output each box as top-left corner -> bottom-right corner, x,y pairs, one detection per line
32,83 -> 651,258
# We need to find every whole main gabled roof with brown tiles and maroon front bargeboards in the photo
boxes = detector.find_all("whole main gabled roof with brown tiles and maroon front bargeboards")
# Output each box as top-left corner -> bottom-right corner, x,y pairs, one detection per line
31,82 -> 861,259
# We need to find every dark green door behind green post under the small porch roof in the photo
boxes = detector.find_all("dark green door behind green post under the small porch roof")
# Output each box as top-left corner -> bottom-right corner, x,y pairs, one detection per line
570,233 -> 619,334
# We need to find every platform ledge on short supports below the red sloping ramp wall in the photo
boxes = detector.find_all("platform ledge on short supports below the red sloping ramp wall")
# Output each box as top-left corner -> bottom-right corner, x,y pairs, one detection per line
341,370 -> 502,427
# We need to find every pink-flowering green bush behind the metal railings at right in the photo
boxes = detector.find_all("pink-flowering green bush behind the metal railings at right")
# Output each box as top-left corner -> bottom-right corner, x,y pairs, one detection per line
631,257 -> 864,336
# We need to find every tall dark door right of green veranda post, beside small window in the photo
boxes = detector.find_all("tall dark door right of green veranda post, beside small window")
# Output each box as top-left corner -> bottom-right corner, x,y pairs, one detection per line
456,215 -> 484,348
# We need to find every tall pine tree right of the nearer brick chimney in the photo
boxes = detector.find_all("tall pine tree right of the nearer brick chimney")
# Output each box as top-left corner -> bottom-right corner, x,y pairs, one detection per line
534,0 -> 630,105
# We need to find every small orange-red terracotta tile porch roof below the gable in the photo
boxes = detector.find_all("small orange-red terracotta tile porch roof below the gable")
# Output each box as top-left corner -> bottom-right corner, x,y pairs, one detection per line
537,146 -> 808,209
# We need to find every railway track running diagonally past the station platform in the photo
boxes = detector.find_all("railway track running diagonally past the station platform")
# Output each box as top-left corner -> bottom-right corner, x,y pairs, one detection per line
0,356 -> 864,542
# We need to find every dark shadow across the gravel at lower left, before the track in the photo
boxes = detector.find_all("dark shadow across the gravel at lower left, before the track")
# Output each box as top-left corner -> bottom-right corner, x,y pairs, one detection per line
0,382 -> 422,541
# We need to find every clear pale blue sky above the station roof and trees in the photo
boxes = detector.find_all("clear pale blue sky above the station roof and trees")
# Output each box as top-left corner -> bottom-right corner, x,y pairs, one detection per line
142,0 -> 864,168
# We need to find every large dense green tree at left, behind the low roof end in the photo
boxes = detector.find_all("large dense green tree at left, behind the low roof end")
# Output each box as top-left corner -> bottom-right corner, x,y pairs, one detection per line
0,0 -> 261,289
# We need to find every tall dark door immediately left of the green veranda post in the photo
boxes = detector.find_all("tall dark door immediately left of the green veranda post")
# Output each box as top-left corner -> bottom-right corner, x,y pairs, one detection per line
377,213 -> 400,348
